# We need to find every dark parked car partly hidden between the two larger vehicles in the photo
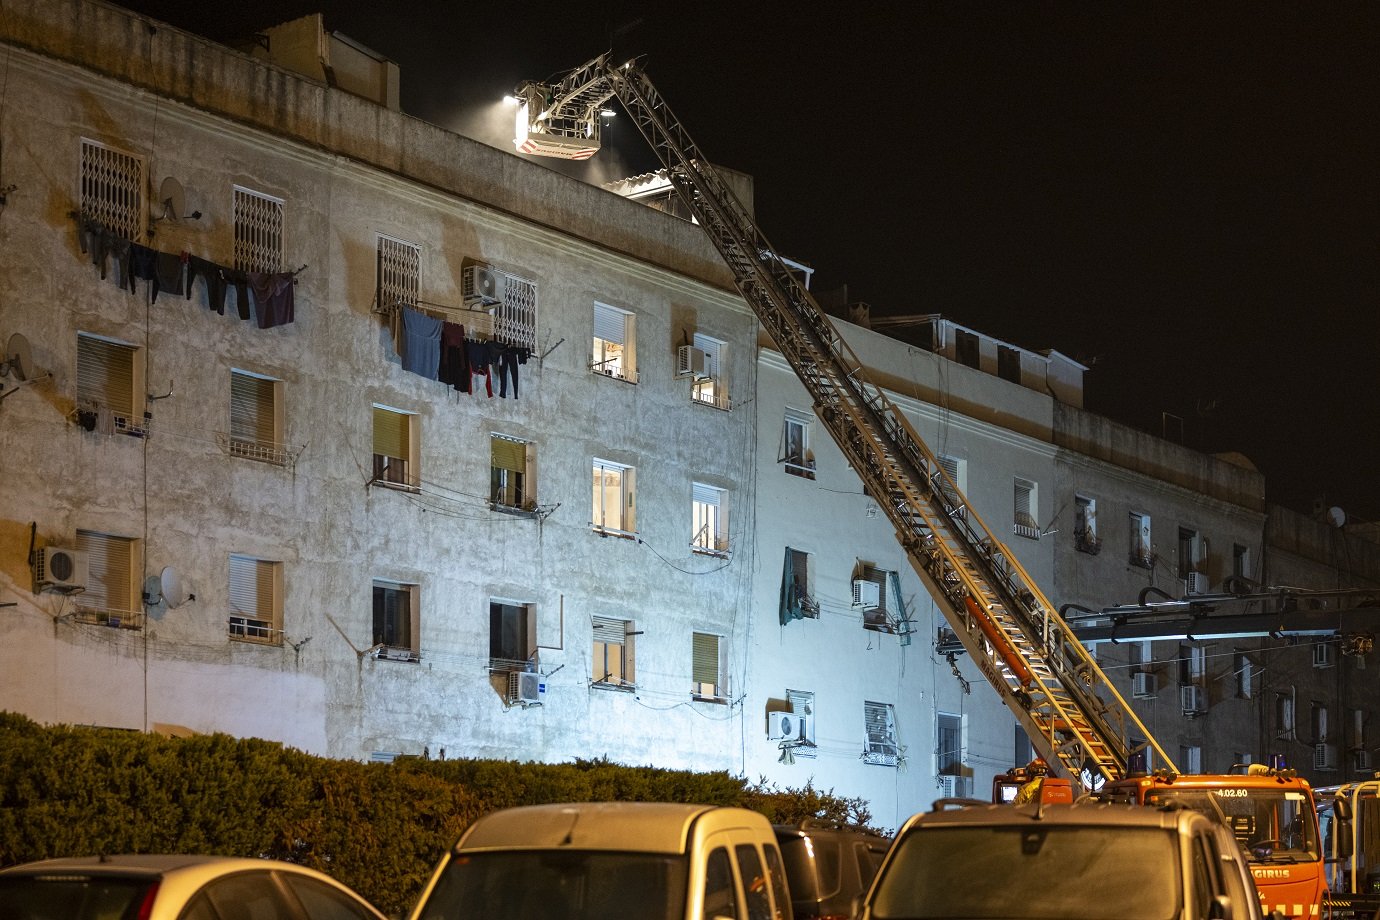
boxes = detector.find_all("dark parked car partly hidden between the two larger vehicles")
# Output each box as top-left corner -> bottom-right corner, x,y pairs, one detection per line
771,822 -> 891,920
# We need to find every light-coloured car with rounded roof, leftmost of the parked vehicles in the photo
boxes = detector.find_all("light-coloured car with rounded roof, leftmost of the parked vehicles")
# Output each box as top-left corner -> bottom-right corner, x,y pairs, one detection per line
0,855 -> 384,920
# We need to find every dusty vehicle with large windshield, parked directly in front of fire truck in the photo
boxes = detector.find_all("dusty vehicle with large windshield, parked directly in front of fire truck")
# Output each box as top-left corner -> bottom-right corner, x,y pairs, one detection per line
861,803 -> 1261,920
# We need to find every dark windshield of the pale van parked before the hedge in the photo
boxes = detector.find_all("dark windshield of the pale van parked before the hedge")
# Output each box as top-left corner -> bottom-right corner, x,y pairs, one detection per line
421,850 -> 687,920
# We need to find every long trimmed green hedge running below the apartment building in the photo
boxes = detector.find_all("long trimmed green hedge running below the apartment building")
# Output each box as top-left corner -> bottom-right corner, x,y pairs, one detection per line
0,712 -> 869,916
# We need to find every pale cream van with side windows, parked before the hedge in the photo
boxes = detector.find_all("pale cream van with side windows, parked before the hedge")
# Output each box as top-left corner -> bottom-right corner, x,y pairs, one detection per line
411,801 -> 791,920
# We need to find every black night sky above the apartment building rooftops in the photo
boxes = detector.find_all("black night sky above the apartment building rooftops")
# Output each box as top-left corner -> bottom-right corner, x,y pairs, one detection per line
110,0 -> 1380,521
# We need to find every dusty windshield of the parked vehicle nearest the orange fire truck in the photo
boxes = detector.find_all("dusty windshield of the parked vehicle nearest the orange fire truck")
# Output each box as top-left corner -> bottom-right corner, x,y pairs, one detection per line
872,825 -> 1181,920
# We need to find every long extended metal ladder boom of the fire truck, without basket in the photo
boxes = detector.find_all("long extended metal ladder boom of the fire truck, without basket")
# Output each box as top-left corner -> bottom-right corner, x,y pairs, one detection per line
527,55 -> 1173,785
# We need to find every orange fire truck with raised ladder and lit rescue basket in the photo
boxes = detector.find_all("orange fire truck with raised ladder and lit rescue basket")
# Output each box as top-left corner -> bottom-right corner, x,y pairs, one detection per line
513,52 -> 1322,919
